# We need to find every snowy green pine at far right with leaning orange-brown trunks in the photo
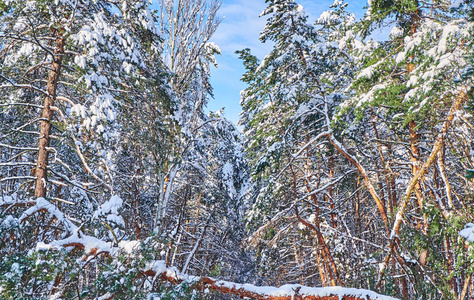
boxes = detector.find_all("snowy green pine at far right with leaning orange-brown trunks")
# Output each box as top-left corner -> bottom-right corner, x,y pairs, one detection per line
335,1 -> 473,298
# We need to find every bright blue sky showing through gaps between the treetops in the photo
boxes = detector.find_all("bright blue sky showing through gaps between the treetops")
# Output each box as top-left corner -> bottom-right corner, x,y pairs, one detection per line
208,0 -> 367,123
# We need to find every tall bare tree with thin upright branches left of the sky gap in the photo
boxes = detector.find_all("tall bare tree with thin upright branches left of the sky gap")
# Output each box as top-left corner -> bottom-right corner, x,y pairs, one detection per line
155,0 -> 220,231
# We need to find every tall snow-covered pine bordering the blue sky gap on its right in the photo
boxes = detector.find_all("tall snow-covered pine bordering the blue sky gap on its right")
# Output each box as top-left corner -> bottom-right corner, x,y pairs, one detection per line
239,1 -> 374,285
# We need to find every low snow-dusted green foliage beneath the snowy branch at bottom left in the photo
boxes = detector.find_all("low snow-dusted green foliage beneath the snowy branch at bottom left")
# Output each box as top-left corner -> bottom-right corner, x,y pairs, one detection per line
0,239 -> 206,299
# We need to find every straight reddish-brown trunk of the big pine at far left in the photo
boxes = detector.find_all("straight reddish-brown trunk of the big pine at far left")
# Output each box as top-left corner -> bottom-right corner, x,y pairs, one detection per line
35,32 -> 65,197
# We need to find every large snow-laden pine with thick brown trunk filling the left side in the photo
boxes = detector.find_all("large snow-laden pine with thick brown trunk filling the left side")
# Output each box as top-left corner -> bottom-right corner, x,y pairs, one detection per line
0,0 -> 178,298
